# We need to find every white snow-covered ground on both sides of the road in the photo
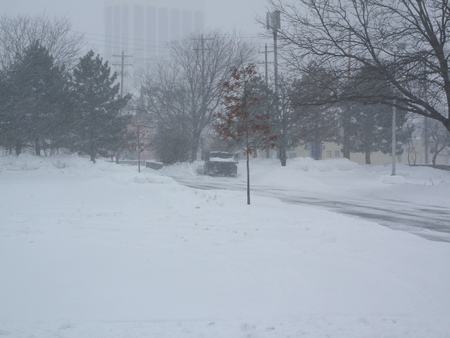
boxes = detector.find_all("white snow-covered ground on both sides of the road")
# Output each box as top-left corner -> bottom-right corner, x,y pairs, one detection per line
0,156 -> 450,338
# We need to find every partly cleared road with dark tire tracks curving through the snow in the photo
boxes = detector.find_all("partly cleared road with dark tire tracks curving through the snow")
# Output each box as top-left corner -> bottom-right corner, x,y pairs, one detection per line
174,176 -> 450,242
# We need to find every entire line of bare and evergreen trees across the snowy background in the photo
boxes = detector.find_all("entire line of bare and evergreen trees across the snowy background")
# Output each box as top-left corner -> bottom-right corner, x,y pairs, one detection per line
0,0 -> 450,165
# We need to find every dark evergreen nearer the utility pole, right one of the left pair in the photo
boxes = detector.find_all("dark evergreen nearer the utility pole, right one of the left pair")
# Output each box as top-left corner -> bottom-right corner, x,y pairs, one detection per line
72,51 -> 131,162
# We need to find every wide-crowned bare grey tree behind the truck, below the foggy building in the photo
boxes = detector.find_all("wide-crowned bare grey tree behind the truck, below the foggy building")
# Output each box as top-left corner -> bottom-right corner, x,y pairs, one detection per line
139,31 -> 255,161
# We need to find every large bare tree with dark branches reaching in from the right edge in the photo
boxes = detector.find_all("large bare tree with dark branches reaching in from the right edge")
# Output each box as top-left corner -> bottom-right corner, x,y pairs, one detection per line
268,0 -> 450,135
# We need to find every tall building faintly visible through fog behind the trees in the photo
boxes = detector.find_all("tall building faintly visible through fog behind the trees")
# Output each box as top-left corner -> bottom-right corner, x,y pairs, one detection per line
105,0 -> 205,66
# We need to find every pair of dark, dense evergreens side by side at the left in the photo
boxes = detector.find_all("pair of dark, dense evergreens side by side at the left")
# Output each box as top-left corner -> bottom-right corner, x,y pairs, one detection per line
0,40 -> 130,162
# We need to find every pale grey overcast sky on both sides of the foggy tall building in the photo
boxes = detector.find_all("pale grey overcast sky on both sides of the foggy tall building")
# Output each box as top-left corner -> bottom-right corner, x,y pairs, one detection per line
0,0 -> 267,49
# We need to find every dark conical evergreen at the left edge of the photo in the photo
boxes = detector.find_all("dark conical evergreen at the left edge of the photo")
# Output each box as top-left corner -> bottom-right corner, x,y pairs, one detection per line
1,41 -> 68,155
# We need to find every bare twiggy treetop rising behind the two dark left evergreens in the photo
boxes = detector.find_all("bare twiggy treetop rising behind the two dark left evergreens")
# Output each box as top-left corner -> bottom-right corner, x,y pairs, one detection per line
0,14 -> 85,69
